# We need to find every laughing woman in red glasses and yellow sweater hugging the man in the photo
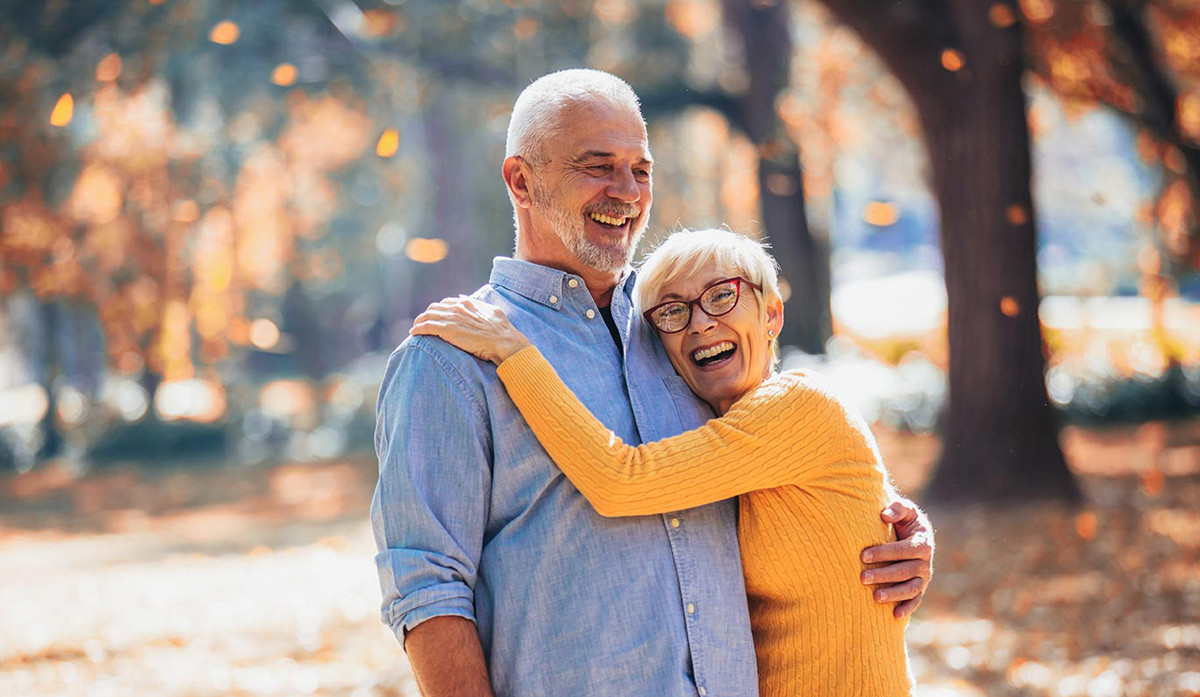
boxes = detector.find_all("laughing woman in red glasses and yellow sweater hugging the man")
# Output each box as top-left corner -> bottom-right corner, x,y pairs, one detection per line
412,230 -> 911,697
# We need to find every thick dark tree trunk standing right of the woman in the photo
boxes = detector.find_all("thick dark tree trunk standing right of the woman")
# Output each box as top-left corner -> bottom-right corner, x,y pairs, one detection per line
827,0 -> 1080,503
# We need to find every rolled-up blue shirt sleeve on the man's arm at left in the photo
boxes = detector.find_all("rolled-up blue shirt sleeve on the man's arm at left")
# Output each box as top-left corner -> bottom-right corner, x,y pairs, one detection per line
371,337 -> 491,643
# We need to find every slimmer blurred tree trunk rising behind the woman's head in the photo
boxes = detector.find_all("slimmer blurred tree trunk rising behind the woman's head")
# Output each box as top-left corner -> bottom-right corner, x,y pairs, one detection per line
724,0 -> 833,354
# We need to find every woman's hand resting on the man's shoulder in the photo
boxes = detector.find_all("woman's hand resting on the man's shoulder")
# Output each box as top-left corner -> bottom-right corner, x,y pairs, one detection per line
408,295 -> 529,365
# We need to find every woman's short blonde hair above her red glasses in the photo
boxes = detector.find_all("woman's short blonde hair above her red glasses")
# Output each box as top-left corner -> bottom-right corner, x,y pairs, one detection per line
634,228 -> 782,356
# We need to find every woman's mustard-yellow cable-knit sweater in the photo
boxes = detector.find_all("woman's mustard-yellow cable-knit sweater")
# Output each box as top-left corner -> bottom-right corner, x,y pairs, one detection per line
498,347 -> 910,697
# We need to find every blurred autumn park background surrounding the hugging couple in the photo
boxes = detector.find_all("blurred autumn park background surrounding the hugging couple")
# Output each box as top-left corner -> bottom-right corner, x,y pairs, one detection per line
0,0 -> 1200,697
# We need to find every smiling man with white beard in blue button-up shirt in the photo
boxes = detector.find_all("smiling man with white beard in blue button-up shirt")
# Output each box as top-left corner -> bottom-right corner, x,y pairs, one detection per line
371,70 -> 932,697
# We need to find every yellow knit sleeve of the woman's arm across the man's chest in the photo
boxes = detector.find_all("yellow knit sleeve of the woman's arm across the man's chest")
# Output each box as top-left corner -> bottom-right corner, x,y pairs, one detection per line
498,347 -> 877,516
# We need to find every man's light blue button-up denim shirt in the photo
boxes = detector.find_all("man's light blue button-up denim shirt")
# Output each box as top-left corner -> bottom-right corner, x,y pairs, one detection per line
371,258 -> 757,697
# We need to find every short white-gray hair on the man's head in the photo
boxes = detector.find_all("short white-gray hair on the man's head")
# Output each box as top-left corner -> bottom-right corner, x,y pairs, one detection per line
504,68 -> 642,164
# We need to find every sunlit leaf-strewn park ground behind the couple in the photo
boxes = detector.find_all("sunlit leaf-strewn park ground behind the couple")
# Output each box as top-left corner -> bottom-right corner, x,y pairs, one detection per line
0,422 -> 1200,697
